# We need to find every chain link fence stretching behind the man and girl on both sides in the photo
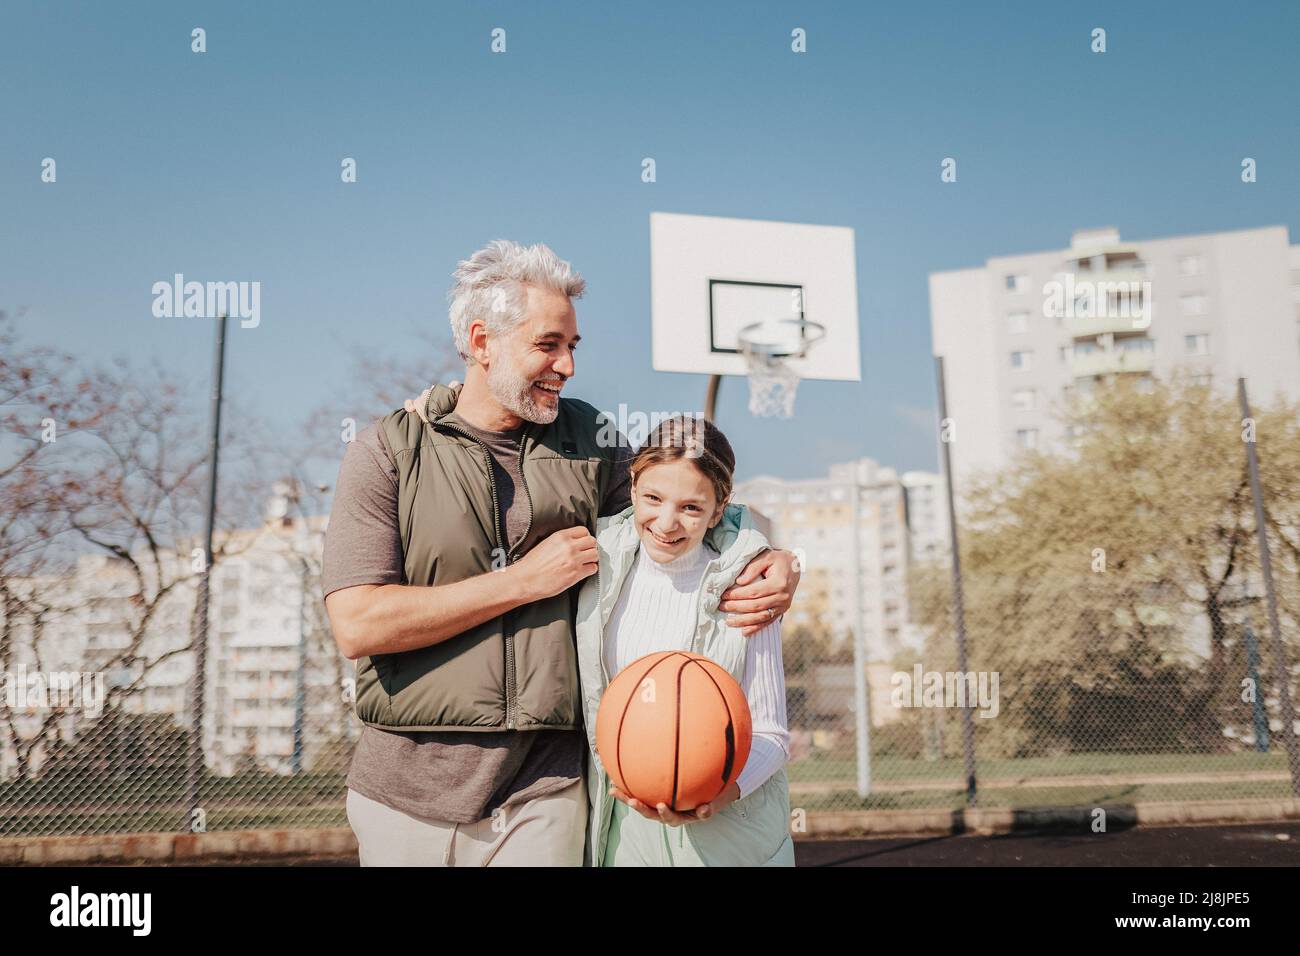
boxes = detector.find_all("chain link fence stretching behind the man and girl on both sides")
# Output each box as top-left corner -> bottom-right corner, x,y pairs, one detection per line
0,385 -> 1300,836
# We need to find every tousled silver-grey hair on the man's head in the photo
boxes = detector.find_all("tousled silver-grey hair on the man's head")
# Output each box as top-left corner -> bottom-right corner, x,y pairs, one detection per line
447,239 -> 586,364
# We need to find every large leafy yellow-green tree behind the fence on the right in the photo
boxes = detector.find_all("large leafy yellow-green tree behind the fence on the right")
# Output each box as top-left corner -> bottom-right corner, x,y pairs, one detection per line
910,377 -> 1300,756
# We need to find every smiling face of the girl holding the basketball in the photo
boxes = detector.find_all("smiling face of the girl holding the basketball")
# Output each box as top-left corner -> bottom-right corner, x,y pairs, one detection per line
632,458 -> 727,563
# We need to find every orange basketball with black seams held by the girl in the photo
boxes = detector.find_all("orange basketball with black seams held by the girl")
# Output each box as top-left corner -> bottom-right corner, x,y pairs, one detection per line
595,650 -> 751,812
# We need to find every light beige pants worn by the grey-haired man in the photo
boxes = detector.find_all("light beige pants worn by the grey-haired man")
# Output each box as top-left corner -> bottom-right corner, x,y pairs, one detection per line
347,780 -> 586,866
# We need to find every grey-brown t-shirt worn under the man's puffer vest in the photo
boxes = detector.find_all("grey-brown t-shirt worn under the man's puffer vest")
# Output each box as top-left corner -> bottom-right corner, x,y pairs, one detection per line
321,412 -> 632,823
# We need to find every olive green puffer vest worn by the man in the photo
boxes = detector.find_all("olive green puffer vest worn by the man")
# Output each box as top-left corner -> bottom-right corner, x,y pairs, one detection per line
356,385 -> 618,731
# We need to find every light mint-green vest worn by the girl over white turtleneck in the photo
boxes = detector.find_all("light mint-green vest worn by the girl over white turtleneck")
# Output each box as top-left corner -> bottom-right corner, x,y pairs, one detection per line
577,505 -> 792,866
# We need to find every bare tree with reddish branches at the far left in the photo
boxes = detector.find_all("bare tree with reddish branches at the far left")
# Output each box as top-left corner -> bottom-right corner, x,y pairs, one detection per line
0,316 -> 279,777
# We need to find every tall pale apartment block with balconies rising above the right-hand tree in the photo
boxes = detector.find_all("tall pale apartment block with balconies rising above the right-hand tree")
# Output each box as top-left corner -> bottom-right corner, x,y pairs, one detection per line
930,226 -> 1300,488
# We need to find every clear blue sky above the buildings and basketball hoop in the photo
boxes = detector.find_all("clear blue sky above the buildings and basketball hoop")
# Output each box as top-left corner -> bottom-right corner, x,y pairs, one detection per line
0,0 -> 1300,477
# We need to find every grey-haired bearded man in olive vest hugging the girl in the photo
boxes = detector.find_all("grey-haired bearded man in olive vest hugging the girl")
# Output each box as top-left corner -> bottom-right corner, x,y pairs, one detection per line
324,241 -> 798,866
